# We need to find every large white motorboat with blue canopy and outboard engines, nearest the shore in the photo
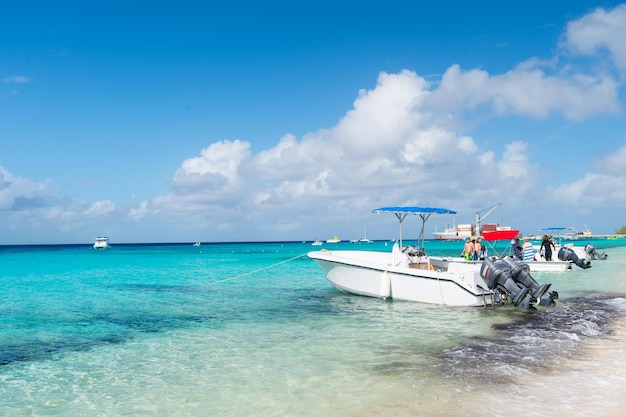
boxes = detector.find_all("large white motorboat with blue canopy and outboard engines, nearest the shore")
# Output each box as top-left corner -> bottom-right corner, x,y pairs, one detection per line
308,207 -> 558,308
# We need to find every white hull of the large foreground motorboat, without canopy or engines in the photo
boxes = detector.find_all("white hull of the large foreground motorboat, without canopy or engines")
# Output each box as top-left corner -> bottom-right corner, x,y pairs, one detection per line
308,251 -> 493,306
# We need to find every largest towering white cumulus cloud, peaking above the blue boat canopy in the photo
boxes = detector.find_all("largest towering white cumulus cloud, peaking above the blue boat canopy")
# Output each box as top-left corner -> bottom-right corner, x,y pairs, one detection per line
131,70 -> 530,224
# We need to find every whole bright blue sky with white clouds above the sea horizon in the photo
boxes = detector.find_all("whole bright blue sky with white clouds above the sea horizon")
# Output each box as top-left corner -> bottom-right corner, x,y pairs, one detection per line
0,0 -> 626,244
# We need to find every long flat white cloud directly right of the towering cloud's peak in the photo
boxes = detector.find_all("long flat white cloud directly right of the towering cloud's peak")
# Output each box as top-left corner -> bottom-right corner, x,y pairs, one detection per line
429,60 -> 621,120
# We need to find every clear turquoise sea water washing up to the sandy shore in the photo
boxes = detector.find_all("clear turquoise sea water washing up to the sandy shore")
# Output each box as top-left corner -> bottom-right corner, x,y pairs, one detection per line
0,240 -> 626,416
